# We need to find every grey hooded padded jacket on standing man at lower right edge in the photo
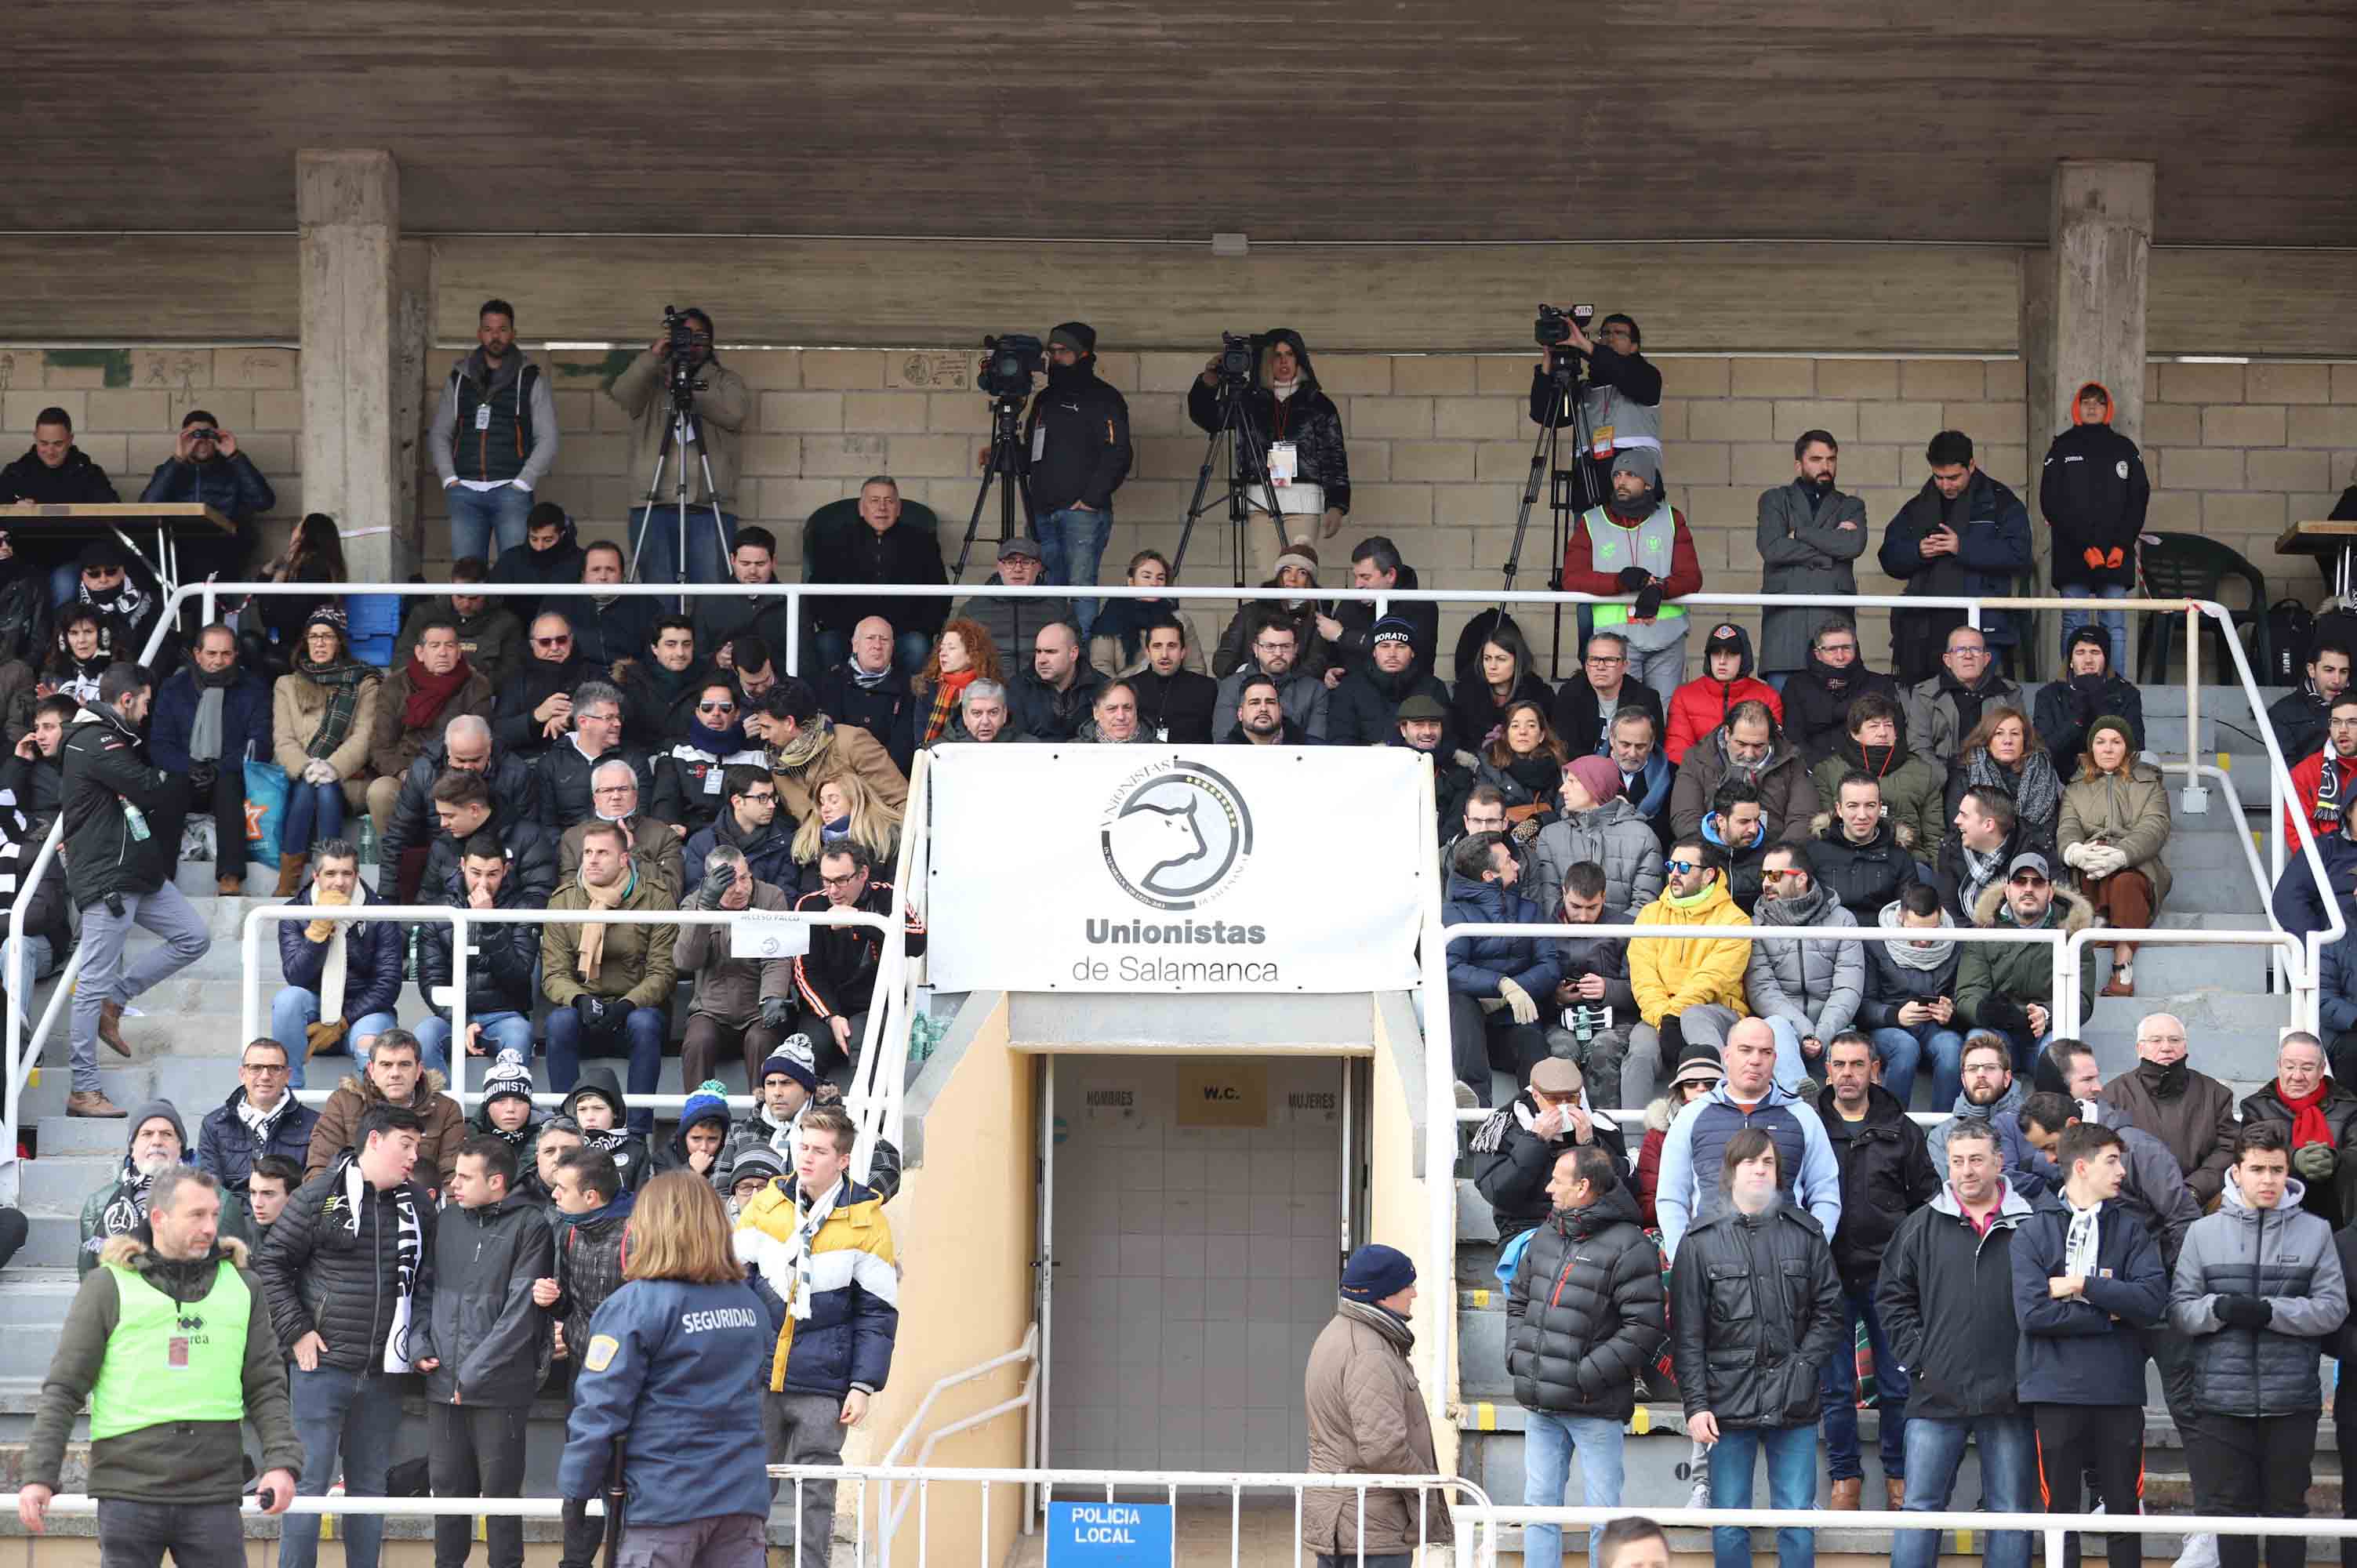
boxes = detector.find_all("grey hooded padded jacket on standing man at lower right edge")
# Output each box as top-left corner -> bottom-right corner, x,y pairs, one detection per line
2169,1170 -> 2350,1417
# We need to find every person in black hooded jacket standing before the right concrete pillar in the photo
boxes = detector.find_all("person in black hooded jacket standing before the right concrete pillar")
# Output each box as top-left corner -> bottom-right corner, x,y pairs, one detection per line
2039,382 -> 2152,674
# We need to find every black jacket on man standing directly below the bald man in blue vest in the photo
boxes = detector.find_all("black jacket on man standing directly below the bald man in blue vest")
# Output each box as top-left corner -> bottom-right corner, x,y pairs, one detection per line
1669,1203 -> 1850,1429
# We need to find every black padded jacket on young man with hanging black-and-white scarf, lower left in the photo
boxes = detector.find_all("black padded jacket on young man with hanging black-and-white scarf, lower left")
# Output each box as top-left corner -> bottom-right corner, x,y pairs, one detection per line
255,1156 -> 436,1374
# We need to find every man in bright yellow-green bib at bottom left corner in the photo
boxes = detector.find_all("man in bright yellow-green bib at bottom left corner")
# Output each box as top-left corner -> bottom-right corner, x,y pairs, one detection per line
16,1165 -> 303,1568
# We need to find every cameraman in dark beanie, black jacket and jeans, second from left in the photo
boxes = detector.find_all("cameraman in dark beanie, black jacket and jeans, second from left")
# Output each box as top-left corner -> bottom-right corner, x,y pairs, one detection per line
1023,321 -> 1129,646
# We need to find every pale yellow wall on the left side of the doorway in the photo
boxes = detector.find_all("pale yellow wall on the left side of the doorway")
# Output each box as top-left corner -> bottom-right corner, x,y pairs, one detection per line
837,997 -> 1040,1568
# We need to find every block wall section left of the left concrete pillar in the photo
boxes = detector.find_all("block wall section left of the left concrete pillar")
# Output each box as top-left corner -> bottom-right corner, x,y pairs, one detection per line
0,347 -> 306,547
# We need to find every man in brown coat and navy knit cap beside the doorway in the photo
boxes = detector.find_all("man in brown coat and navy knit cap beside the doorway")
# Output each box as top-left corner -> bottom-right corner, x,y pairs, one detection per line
1301,1243 -> 1455,1568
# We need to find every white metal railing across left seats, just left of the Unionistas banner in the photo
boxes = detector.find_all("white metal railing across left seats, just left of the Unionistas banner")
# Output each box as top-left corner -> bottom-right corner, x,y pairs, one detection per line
238,903 -> 905,1181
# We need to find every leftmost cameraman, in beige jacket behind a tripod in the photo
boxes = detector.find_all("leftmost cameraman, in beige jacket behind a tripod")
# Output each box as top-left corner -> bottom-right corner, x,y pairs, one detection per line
606,307 -> 752,583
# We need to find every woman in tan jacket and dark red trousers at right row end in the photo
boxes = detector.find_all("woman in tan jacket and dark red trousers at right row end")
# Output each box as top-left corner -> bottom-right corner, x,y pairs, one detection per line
2062,714 -> 2174,997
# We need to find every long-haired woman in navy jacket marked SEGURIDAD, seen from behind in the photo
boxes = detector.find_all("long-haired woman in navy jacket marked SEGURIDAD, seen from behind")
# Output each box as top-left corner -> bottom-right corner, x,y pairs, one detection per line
556,1170 -> 783,1568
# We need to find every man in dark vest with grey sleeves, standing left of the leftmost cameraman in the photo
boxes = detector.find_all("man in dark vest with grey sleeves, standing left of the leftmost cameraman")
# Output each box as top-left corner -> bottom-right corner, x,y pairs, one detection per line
427,299 -> 556,559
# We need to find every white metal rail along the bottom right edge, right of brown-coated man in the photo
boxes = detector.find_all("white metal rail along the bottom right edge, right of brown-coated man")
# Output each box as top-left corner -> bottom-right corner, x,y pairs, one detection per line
1452,1502 -> 2357,1568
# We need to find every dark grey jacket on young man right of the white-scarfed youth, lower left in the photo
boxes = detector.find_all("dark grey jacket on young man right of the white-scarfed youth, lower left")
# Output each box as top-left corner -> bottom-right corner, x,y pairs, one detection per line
410,1193 -> 556,1407
